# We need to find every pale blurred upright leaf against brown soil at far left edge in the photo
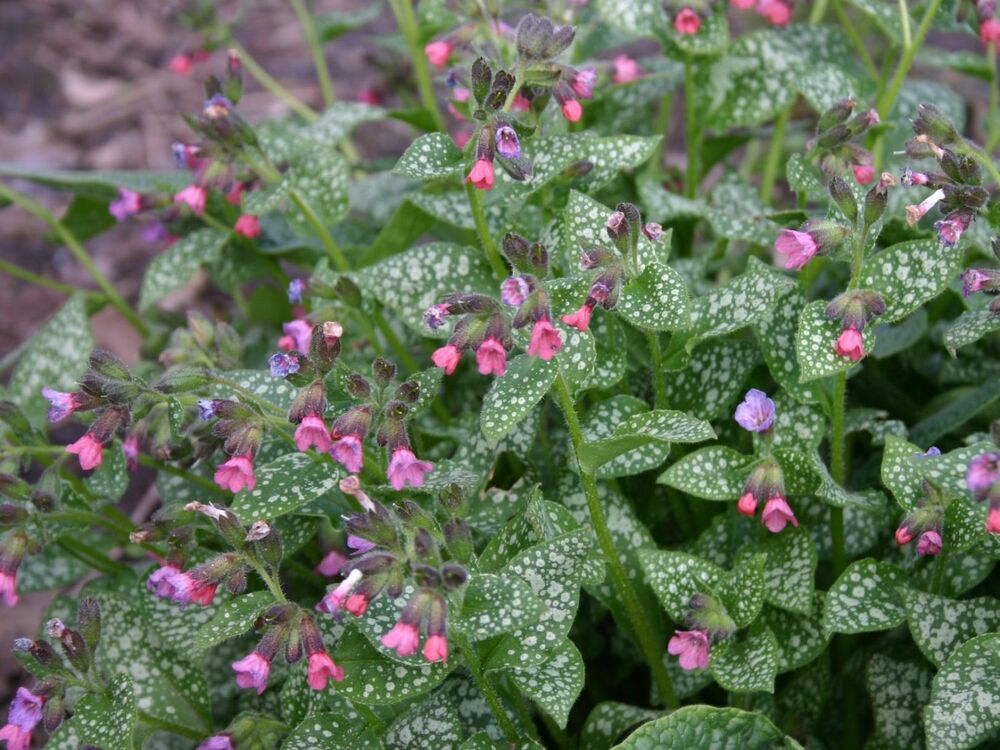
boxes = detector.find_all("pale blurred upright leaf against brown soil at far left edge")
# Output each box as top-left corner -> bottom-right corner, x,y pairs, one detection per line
7,295 -> 94,427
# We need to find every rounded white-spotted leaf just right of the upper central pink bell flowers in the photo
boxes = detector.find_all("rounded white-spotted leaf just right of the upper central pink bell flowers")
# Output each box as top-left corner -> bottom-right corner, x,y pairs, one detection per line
616,263 -> 691,331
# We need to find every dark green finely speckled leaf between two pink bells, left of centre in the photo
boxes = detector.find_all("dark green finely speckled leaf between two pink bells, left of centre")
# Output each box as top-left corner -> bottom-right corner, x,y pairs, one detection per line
231,453 -> 343,524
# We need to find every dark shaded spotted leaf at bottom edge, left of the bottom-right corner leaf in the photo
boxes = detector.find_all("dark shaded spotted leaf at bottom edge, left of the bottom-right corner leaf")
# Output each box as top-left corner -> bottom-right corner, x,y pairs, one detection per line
865,654 -> 931,750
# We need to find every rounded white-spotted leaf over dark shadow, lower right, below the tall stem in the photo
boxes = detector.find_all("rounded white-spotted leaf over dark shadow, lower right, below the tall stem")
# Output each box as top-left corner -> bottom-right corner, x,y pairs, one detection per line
823,559 -> 906,633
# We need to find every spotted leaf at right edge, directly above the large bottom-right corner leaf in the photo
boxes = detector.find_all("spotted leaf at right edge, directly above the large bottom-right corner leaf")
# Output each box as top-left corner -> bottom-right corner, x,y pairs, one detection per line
902,589 -> 1000,667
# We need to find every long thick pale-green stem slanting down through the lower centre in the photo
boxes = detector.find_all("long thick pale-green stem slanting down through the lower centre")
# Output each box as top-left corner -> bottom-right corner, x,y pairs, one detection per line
555,375 -> 680,709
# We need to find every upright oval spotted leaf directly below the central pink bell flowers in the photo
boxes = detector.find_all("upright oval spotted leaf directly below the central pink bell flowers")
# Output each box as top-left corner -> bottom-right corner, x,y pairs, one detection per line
479,354 -> 559,446
